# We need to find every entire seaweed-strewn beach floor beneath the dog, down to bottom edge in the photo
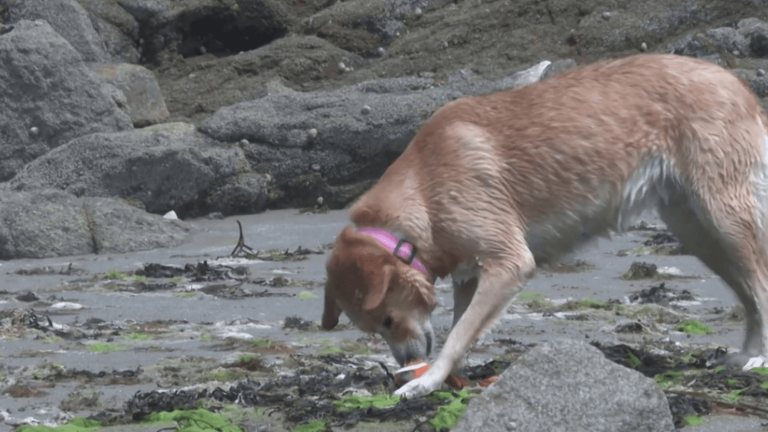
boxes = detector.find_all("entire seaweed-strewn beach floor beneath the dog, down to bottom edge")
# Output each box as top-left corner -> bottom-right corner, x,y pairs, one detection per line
0,210 -> 768,431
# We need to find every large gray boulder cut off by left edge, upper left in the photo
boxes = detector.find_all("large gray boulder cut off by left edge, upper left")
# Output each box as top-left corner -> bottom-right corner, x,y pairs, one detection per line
0,21 -> 132,181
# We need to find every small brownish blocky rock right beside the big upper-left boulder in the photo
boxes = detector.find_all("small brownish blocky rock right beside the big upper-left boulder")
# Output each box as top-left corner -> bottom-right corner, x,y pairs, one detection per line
91,63 -> 168,127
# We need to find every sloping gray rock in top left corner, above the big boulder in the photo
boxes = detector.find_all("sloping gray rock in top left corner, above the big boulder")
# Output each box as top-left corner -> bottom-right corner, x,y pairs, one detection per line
6,0 -> 109,62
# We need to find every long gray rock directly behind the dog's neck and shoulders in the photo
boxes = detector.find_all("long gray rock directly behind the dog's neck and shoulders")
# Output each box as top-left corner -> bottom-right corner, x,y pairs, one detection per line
200,62 -> 549,207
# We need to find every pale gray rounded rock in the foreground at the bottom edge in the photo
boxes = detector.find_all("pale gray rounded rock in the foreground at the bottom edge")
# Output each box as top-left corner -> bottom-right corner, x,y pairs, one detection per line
454,339 -> 675,432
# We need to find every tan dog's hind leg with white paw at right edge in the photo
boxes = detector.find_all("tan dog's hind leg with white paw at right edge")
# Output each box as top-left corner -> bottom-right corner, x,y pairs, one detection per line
659,188 -> 768,368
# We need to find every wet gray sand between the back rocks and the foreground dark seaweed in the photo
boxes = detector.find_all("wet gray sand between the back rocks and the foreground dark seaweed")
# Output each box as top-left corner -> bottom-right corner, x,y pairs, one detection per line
0,210 -> 759,430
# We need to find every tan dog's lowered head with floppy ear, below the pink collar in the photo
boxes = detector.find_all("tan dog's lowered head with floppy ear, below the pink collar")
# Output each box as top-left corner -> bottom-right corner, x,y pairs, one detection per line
323,227 -> 436,365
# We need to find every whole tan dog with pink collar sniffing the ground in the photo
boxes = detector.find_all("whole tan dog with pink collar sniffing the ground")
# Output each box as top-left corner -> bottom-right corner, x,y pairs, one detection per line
323,55 -> 768,395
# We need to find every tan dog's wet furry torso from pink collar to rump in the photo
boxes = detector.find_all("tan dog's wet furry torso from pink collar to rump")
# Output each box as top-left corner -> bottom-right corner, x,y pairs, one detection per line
352,55 -> 765,260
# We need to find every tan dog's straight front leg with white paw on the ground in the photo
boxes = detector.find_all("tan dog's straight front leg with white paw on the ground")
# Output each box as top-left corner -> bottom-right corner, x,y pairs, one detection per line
395,253 -> 535,396
